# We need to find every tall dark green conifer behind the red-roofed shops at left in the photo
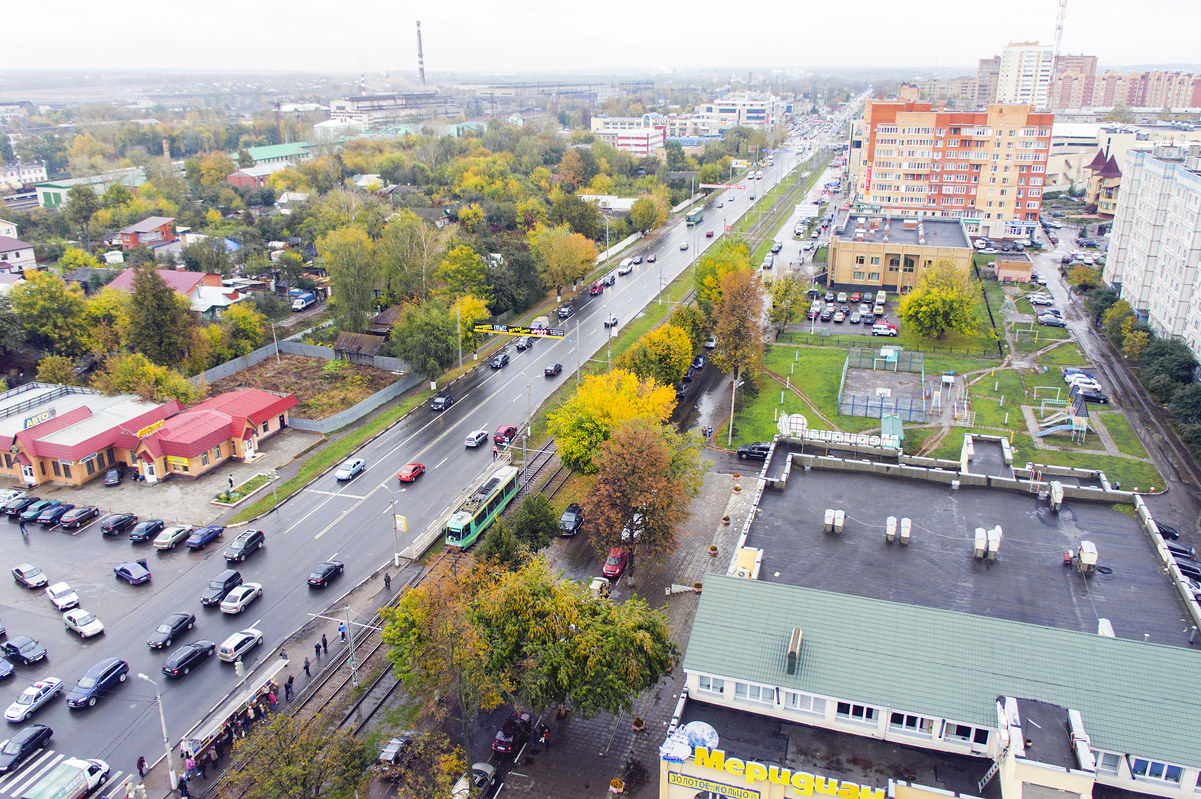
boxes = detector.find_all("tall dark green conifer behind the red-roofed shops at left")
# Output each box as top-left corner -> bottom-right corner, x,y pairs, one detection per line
126,263 -> 192,366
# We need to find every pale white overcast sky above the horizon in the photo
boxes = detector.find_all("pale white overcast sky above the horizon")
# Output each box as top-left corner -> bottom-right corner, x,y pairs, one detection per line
9,0 -> 1201,73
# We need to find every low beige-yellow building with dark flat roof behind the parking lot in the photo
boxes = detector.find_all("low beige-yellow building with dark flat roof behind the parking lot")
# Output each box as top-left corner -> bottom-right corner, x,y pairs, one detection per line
826,211 -> 972,293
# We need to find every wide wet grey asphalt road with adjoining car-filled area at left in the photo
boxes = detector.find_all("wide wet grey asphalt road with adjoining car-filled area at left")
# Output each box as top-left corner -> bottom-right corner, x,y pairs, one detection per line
0,126 -> 859,783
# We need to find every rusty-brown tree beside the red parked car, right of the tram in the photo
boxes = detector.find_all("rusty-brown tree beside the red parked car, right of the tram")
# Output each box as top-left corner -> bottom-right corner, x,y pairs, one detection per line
584,417 -> 705,560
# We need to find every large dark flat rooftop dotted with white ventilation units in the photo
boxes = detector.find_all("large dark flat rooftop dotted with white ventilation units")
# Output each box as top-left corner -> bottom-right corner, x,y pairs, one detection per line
747,468 -> 1191,645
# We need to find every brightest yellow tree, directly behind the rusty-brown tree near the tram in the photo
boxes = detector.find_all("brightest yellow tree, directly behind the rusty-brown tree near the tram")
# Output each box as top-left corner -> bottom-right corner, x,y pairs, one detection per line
546,369 -> 675,475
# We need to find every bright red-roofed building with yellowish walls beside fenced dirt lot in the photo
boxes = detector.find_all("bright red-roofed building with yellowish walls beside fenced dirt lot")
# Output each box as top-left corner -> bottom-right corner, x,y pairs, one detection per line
135,388 -> 297,483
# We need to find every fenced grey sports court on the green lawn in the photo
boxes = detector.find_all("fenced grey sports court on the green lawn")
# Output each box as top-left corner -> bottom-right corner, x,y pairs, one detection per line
838,345 -> 938,423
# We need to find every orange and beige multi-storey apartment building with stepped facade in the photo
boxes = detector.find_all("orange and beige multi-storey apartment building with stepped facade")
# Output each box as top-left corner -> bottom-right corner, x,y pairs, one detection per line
850,100 -> 1054,237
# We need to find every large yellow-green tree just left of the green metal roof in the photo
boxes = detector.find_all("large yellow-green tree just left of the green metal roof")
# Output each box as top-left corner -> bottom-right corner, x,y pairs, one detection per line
471,559 -> 680,718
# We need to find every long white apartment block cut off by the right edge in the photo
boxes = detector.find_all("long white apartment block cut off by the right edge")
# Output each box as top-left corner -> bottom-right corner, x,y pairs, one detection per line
1103,143 -> 1201,358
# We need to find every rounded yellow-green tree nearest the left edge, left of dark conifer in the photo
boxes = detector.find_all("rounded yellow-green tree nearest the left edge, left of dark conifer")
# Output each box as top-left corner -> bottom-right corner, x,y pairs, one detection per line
11,272 -> 88,357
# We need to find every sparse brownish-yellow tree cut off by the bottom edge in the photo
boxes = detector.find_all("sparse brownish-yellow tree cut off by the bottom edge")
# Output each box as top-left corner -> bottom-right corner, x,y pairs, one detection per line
217,712 -> 374,799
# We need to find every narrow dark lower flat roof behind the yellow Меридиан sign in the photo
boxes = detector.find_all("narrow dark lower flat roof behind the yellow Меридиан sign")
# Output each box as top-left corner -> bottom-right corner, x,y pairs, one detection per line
680,698 -> 1000,799
